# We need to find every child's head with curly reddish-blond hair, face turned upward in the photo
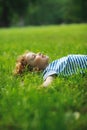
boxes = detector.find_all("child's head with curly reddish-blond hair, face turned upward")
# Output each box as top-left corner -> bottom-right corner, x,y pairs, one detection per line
14,52 -> 49,74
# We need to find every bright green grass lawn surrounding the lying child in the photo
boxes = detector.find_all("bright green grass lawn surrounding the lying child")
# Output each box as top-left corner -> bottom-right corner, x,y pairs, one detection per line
0,24 -> 87,130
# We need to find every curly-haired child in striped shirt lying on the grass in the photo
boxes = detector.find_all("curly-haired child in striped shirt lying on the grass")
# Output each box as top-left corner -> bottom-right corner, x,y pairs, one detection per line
14,52 -> 87,87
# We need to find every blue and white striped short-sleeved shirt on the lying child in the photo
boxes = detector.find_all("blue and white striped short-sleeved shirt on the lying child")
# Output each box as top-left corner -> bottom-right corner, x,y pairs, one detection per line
43,55 -> 87,80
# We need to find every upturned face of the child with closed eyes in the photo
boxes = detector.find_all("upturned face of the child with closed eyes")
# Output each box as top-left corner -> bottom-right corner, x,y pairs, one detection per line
26,52 -> 49,69
